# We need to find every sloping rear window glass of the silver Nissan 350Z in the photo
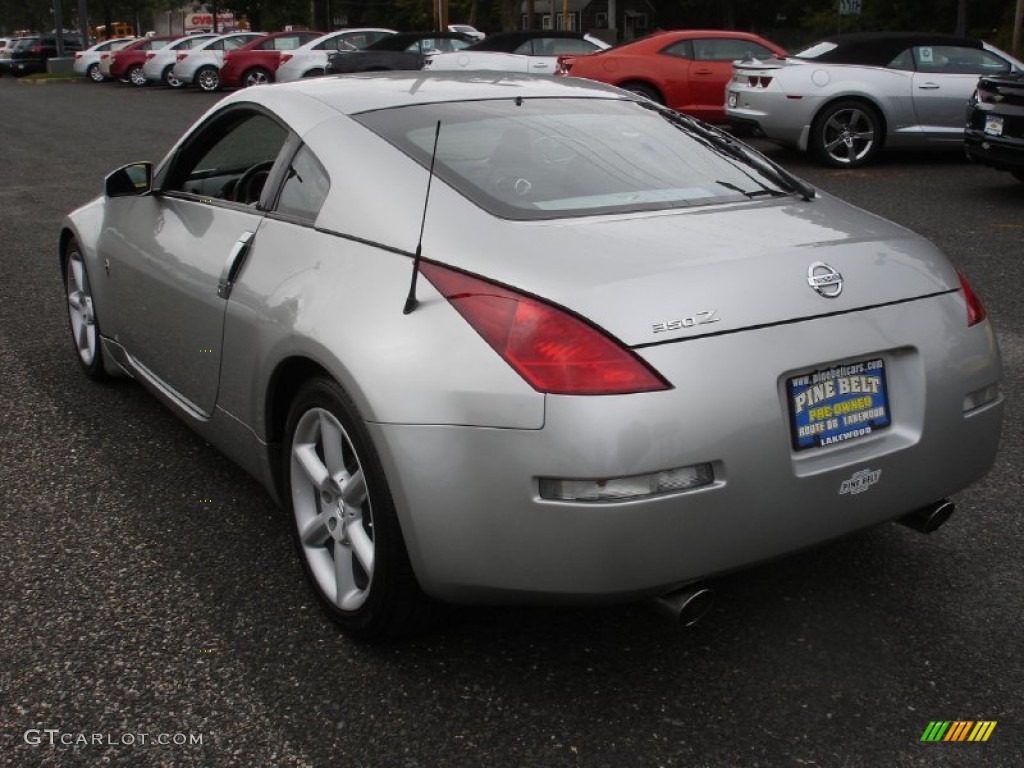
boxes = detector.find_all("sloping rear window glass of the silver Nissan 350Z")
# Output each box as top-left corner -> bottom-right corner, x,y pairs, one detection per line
356,98 -> 788,219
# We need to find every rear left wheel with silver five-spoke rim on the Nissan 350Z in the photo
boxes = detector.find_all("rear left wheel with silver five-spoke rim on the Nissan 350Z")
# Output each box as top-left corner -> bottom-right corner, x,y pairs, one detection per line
283,378 -> 431,641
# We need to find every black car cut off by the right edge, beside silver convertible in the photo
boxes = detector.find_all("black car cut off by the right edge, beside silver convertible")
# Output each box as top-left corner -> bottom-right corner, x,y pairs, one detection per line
964,72 -> 1024,181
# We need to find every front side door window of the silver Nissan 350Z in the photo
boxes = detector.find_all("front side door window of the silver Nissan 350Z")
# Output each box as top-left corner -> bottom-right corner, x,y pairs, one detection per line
162,110 -> 288,204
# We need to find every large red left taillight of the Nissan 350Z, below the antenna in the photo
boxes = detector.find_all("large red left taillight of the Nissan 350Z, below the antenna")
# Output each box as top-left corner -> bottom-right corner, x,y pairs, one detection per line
420,262 -> 670,394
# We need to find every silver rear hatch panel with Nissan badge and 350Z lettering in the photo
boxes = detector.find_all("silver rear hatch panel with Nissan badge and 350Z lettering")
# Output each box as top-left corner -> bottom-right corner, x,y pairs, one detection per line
424,195 -> 958,346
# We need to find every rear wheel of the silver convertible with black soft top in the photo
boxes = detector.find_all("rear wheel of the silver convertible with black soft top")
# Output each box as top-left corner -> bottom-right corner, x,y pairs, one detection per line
810,100 -> 882,168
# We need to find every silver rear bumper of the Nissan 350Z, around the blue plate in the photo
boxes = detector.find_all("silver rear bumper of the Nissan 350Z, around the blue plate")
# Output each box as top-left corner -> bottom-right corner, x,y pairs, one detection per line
371,294 -> 1004,602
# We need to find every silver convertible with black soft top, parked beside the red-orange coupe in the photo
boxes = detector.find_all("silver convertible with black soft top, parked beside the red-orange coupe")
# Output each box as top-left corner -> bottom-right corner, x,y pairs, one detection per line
725,33 -> 1024,168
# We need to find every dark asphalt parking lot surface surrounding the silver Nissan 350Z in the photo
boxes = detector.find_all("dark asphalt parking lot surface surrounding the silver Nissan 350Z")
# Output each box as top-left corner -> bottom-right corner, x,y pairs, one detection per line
6,79 -> 1024,766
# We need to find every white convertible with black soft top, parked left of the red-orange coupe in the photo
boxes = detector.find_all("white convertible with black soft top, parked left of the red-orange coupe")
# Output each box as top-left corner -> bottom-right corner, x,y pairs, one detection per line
423,30 -> 610,75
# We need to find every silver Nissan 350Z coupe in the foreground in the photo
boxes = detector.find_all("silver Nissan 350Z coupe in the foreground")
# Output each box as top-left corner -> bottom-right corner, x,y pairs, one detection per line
57,73 -> 1004,638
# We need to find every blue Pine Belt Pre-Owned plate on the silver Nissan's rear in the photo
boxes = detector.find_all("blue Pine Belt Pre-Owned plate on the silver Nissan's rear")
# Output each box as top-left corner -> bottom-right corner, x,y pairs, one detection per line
785,358 -> 892,451
